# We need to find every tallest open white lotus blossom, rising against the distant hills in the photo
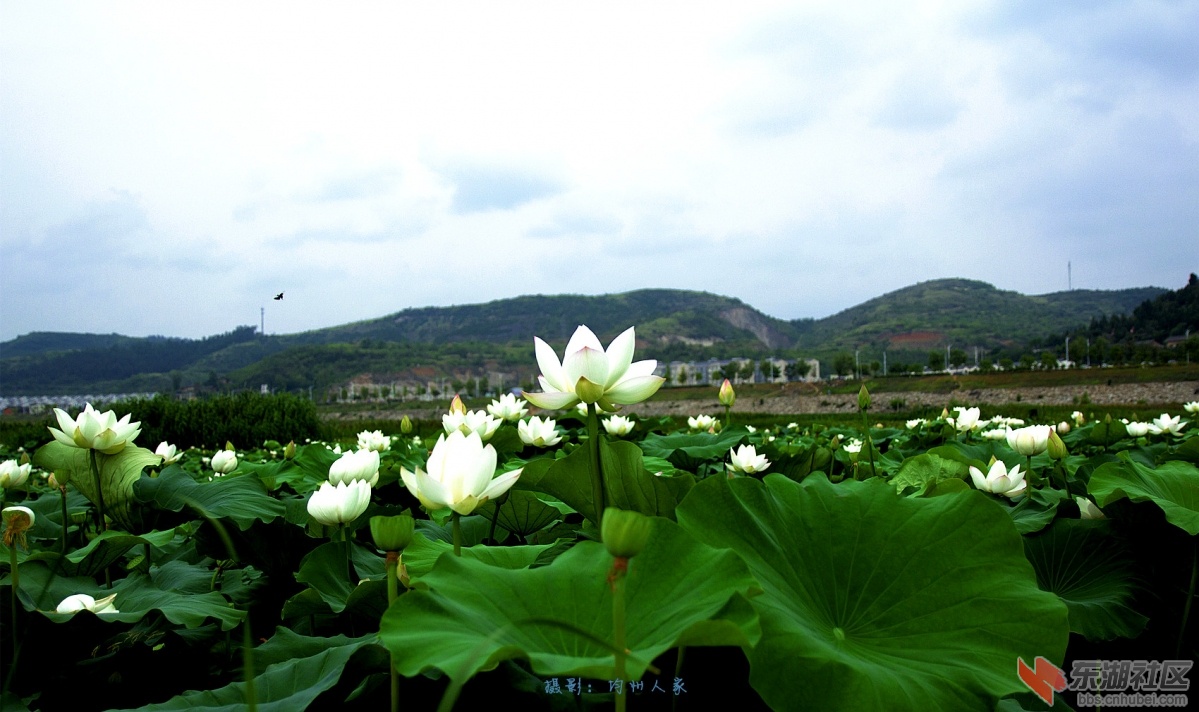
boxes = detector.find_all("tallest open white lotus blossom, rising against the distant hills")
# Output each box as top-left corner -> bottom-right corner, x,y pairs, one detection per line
524,326 -> 665,411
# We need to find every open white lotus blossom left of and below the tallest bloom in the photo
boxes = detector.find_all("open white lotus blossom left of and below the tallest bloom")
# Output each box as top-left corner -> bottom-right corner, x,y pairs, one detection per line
399,430 -> 522,517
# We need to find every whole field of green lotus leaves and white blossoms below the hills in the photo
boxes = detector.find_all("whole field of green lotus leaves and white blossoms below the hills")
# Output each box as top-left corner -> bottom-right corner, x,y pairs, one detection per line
0,327 -> 1199,712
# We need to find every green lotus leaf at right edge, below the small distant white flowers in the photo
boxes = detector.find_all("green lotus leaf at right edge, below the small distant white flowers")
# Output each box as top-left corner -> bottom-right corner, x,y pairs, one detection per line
1086,453 -> 1199,536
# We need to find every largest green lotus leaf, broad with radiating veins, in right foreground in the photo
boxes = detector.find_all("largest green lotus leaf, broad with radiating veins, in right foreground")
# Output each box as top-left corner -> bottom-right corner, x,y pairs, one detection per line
679,475 -> 1070,711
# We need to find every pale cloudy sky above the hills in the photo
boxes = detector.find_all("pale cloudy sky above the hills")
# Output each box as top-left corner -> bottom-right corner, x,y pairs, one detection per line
0,0 -> 1199,340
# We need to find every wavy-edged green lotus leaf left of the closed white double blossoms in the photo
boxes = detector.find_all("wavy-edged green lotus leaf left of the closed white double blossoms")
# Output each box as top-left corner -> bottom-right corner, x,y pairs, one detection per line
134,467 -> 287,531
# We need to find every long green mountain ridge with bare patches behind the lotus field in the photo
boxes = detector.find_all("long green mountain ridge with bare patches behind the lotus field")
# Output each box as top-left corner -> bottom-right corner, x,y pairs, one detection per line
0,279 -> 1168,396
